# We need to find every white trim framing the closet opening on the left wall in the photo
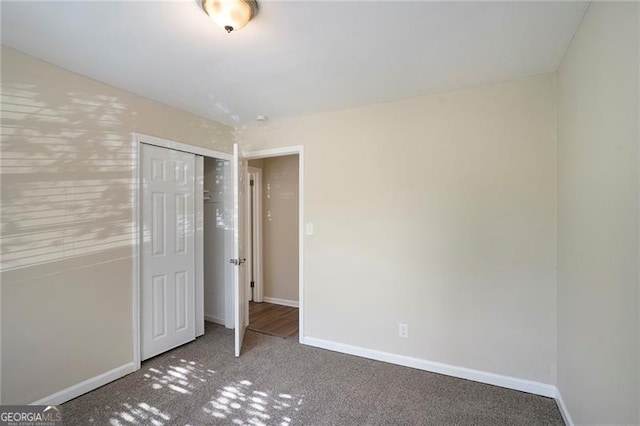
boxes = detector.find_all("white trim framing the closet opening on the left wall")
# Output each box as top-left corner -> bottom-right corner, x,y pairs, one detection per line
131,132 -> 233,370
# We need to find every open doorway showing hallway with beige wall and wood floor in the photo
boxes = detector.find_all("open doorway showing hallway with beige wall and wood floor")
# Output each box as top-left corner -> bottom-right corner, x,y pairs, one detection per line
245,152 -> 302,342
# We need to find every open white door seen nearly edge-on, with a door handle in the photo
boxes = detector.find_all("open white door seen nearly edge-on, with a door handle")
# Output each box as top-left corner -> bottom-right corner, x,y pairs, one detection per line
230,144 -> 249,356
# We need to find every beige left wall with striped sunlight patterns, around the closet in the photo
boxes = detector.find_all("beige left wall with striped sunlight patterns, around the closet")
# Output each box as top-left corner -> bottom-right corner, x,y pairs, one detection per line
1,48 -> 233,404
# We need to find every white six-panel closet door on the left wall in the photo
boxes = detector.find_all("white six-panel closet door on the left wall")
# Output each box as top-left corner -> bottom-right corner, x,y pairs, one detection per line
140,144 -> 195,360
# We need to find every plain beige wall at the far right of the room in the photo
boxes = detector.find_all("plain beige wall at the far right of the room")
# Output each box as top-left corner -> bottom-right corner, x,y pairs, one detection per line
558,3 -> 640,424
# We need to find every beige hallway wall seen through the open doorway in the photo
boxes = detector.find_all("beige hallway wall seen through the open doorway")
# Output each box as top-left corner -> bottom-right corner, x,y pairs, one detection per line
262,155 -> 299,302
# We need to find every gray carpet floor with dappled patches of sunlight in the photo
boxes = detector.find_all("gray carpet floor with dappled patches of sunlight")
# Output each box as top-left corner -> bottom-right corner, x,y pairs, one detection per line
62,323 -> 563,426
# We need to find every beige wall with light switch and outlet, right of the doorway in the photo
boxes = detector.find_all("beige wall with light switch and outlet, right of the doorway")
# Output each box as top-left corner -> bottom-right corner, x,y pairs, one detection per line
238,74 -> 556,384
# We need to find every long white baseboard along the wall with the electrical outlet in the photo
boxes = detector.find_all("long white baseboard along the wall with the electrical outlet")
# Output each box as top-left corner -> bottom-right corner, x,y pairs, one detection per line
302,337 -> 557,398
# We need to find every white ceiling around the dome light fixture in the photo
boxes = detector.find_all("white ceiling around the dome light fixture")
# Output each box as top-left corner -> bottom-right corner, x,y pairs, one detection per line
1,0 -> 587,124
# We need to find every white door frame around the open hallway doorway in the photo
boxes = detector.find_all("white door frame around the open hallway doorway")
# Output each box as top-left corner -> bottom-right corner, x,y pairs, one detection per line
242,145 -> 305,344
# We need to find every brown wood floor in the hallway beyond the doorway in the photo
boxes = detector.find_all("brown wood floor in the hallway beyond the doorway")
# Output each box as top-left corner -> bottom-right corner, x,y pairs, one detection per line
247,302 -> 299,340
